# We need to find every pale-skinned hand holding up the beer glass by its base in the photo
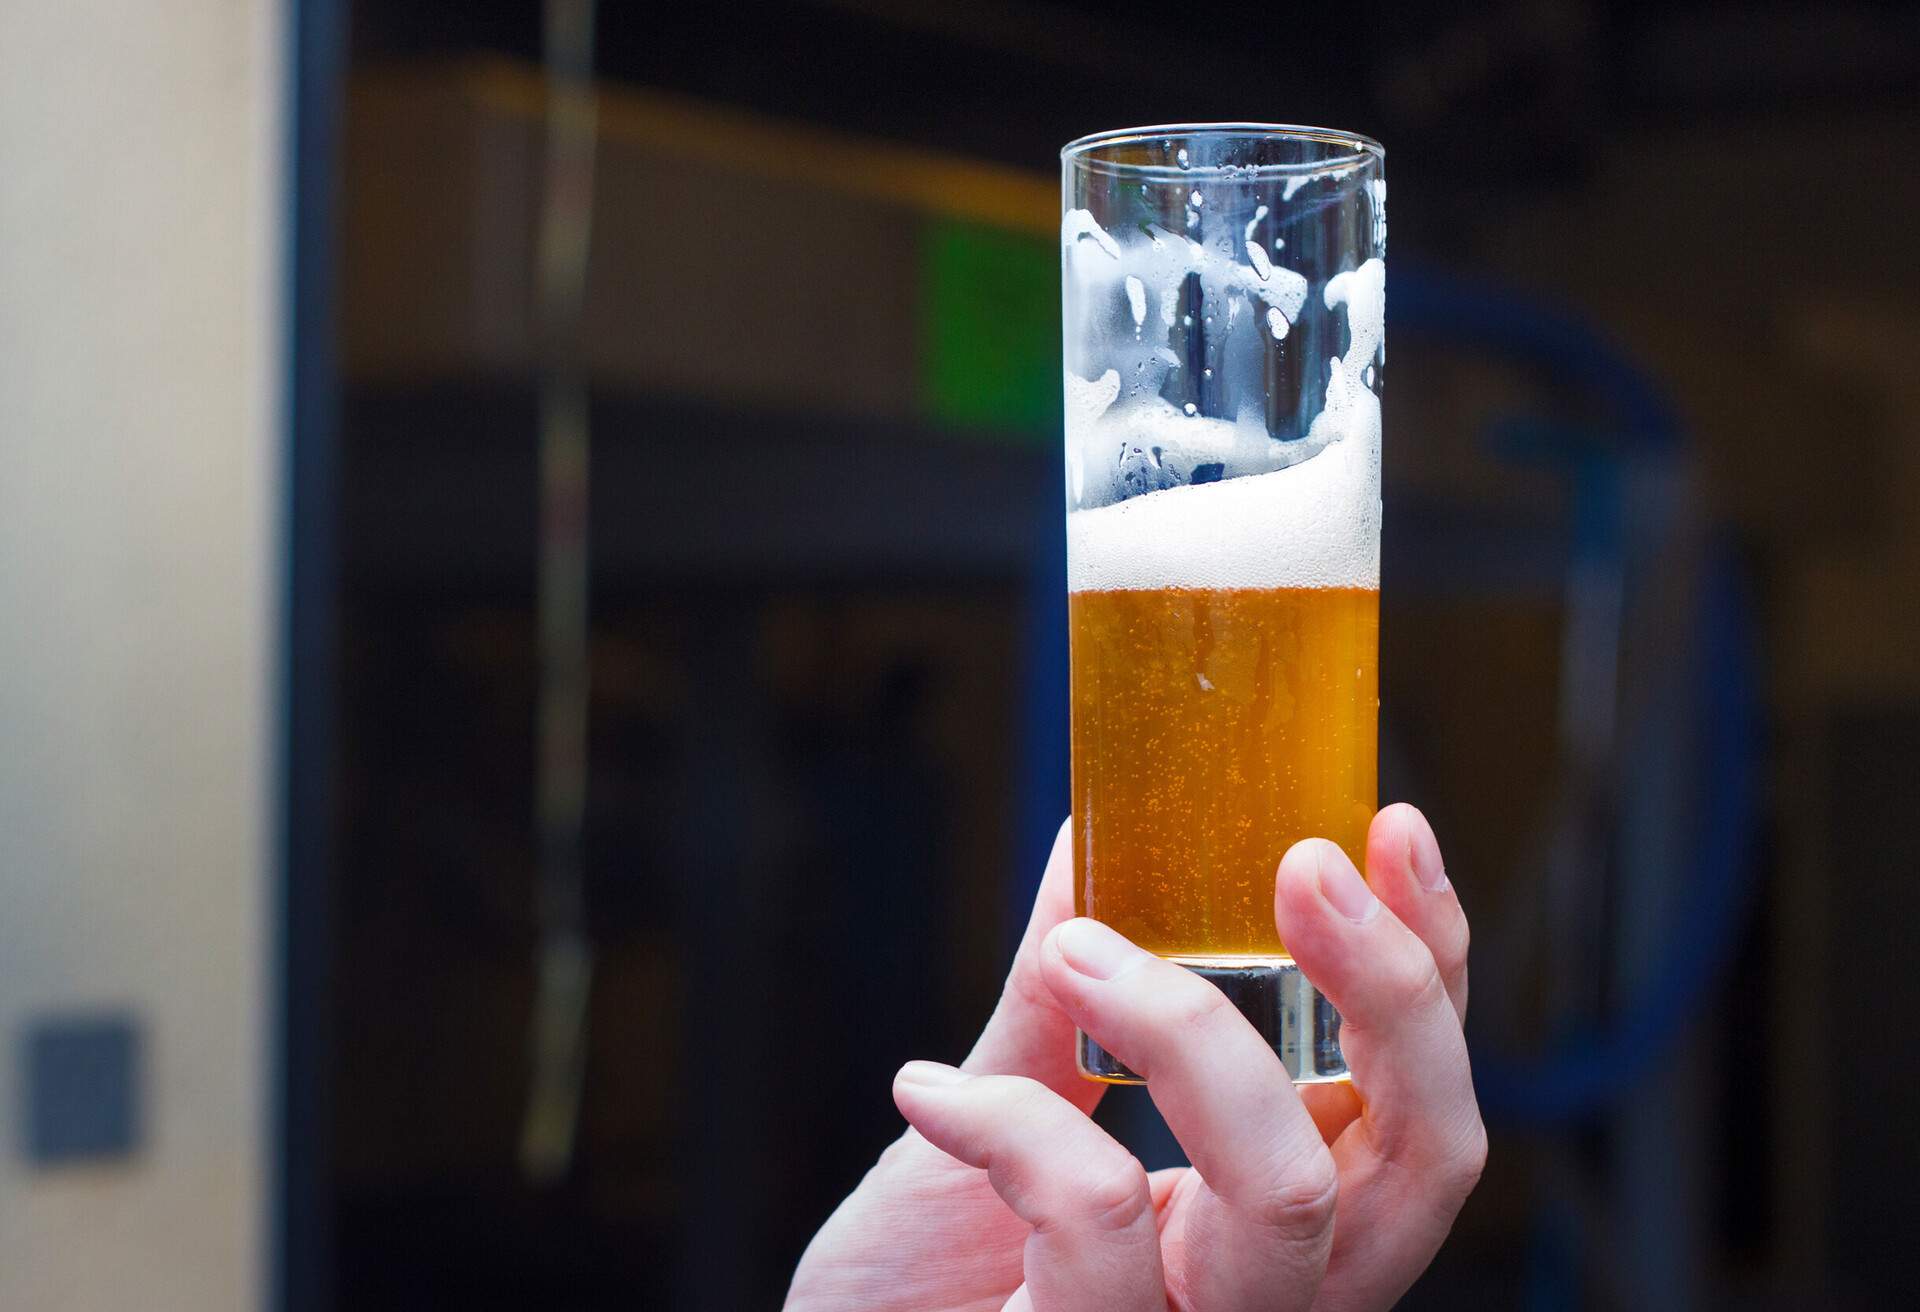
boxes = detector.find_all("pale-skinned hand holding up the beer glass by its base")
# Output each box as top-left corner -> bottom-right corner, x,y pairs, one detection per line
787,805 -> 1486,1312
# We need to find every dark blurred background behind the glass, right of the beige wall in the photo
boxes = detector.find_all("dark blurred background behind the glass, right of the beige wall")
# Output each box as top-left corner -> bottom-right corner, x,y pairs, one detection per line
282,0 -> 1920,1308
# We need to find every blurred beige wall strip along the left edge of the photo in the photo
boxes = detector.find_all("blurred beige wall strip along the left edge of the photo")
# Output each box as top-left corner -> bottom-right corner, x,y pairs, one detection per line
0,0 -> 284,1312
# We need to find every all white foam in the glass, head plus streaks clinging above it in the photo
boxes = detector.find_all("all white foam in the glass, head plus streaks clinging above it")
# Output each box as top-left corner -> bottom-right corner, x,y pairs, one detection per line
1064,211 -> 1386,592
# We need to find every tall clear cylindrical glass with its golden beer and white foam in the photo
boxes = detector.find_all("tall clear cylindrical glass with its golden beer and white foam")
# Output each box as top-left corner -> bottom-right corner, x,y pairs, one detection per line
1060,123 -> 1386,1083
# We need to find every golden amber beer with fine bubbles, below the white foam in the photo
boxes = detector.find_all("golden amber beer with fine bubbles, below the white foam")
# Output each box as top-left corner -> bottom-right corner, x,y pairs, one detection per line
1068,588 -> 1380,964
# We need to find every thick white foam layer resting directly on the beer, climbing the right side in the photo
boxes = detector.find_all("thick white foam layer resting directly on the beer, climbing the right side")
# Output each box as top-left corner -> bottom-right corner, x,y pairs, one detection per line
1068,259 -> 1386,592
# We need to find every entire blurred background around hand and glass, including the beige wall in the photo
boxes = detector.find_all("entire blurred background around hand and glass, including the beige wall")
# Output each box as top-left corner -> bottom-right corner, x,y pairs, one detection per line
0,0 -> 1920,1312
